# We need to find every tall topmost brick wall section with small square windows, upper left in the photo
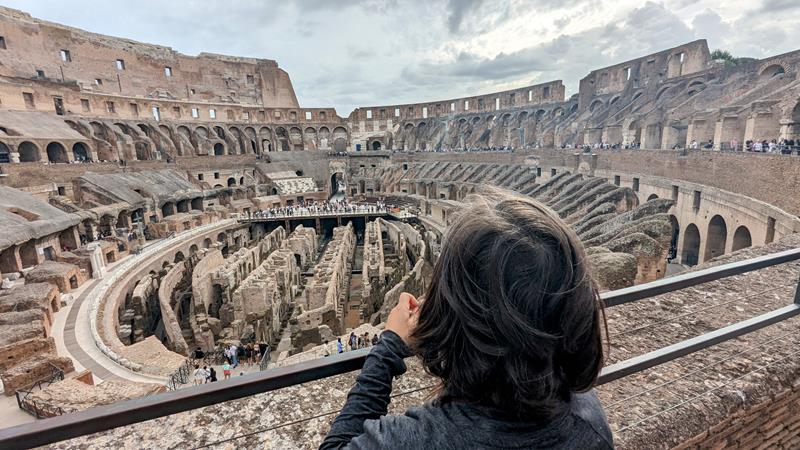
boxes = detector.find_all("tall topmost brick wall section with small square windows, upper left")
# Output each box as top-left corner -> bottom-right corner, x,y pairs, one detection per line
0,8 -> 297,107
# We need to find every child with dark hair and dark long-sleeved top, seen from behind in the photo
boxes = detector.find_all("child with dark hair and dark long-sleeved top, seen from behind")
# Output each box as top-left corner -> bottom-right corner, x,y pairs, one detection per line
320,191 -> 613,449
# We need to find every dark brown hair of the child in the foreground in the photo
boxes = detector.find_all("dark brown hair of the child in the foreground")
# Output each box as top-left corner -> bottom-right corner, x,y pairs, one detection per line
411,190 -> 605,420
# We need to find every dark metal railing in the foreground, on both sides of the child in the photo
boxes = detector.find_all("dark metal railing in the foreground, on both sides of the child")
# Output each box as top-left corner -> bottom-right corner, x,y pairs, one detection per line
0,248 -> 800,449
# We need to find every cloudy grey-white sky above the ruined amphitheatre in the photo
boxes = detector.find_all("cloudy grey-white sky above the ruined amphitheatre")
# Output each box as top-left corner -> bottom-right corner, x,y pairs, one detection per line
0,0 -> 800,116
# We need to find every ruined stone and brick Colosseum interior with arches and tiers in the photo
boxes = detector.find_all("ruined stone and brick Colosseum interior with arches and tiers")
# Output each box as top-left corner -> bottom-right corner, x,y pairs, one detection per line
0,4 -> 800,449
